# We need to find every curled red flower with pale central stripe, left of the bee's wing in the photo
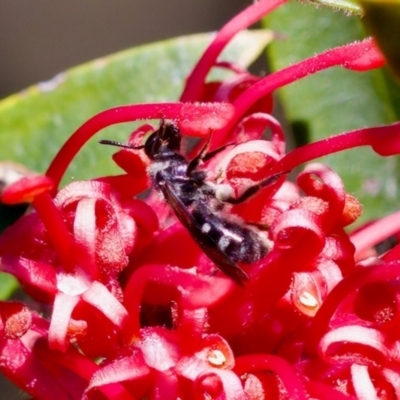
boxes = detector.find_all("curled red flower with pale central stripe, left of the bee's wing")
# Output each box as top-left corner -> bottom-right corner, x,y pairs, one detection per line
55,181 -> 137,279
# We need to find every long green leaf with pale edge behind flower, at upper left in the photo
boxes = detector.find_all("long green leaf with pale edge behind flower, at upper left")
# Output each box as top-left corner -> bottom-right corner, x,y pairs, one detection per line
0,30 -> 271,183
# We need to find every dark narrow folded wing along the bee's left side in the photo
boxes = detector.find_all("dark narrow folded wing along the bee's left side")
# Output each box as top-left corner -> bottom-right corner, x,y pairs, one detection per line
158,181 -> 249,286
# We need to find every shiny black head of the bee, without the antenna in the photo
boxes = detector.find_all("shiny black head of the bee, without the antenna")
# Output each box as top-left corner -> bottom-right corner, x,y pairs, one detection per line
144,121 -> 181,159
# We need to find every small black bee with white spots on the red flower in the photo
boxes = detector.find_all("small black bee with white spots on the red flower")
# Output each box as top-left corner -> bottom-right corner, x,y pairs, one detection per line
100,122 -> 281,286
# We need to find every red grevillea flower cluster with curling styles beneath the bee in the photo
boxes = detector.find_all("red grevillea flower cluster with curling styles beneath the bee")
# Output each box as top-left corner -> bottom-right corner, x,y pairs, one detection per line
0,0 -> 400,400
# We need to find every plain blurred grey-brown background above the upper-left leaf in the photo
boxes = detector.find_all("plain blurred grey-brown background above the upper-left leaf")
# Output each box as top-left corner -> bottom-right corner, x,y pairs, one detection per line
0,0 -> 247,98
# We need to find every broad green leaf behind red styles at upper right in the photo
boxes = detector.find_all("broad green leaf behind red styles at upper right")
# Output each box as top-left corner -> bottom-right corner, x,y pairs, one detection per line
268,3 -> 400,223
